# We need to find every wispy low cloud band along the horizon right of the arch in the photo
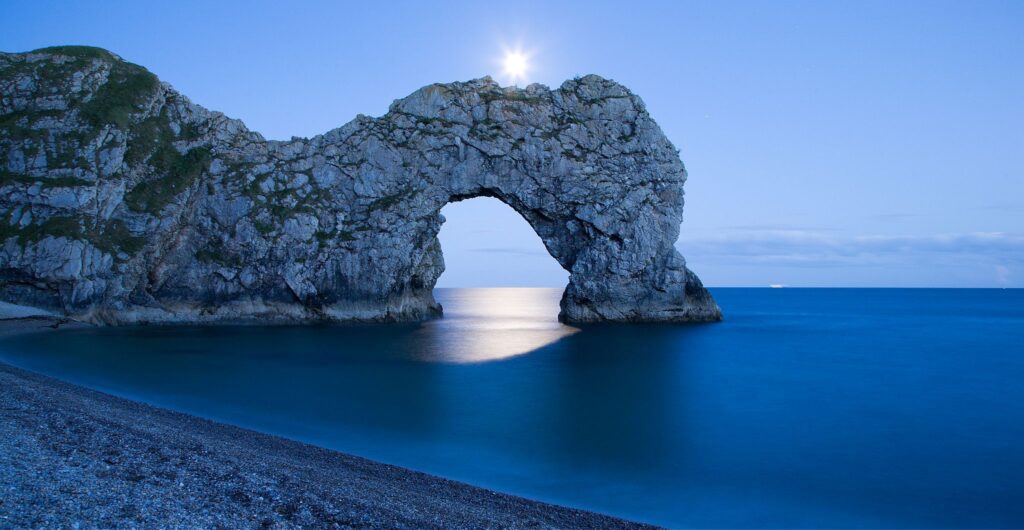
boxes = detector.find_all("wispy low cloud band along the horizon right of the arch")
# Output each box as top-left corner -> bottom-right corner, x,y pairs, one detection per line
677,229 -> 1024,286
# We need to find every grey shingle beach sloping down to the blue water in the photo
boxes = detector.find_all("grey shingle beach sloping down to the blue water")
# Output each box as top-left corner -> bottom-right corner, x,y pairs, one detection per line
0,318 -> 644,529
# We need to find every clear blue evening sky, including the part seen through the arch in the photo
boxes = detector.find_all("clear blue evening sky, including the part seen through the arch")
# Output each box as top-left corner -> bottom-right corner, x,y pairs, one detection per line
0,0 -> 1024,288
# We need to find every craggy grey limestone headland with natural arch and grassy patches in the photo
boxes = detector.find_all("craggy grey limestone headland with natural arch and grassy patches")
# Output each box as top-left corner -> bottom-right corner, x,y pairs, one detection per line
0,47 -> 721,323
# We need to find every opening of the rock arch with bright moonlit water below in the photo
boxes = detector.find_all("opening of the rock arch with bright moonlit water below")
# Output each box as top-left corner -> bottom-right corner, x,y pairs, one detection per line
428,196 -> 578,362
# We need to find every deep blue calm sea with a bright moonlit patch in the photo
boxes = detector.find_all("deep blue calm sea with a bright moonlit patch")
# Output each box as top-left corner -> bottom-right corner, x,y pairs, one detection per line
0,289 -> 1024,528
